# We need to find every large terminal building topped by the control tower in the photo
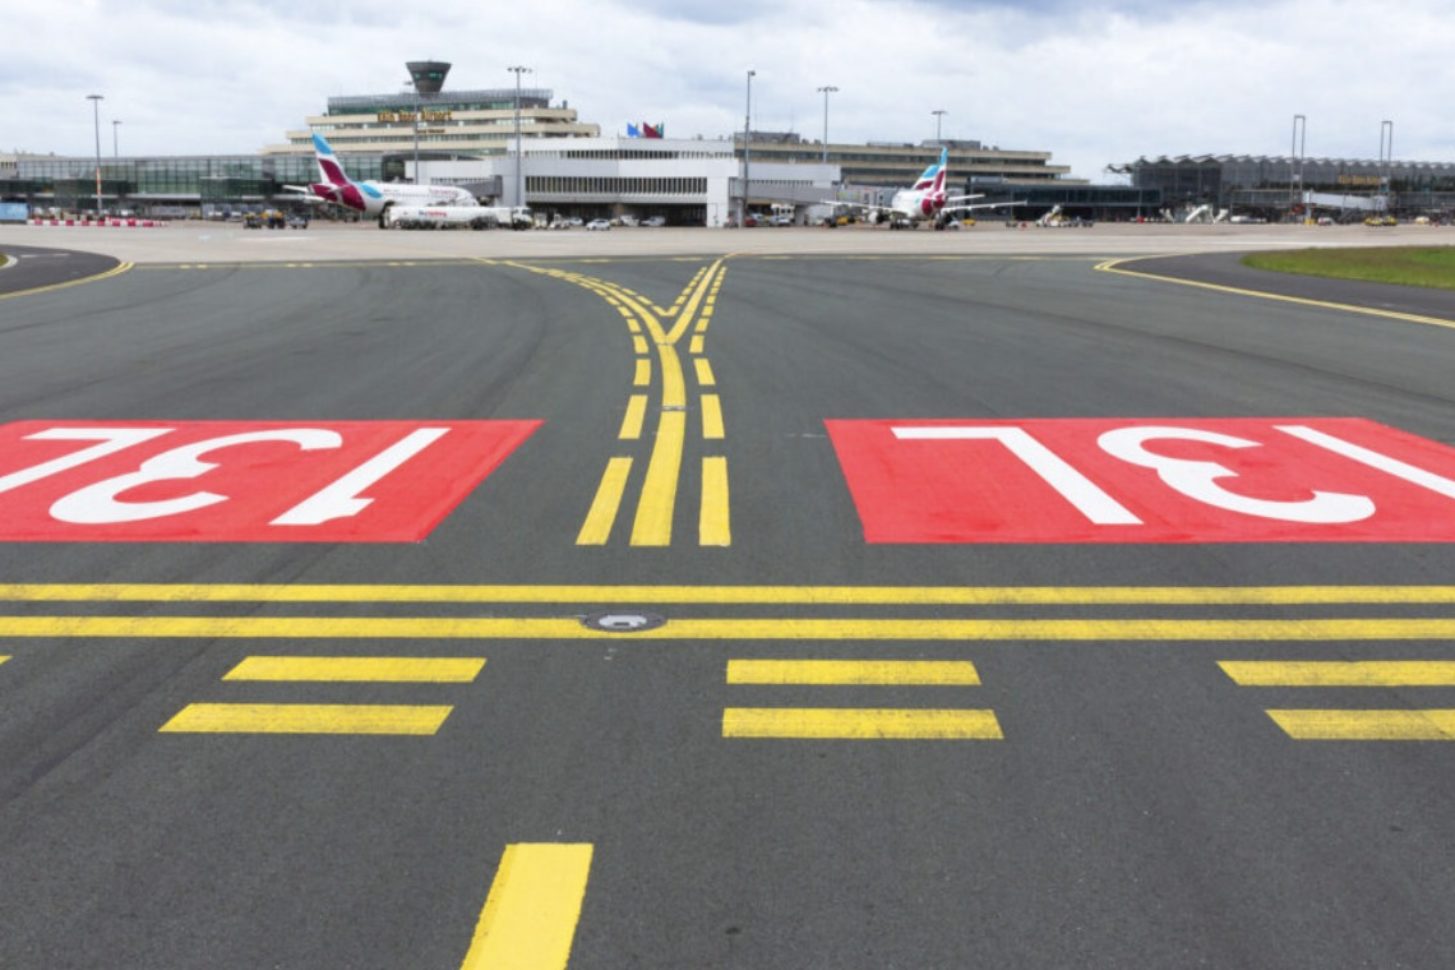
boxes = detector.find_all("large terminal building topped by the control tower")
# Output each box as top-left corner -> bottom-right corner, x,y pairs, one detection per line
0,61 -> 1084,225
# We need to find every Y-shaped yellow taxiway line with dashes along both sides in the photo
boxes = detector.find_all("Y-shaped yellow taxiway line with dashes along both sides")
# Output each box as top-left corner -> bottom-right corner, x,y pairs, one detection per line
509,259 -> 732,547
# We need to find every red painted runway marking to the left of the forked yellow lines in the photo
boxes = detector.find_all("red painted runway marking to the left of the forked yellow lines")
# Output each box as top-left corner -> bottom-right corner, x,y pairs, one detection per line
0,420 -> 540,542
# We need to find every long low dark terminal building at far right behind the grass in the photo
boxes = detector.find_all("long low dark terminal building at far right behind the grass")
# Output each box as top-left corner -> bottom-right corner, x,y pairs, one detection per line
1112,156 -> 1455,220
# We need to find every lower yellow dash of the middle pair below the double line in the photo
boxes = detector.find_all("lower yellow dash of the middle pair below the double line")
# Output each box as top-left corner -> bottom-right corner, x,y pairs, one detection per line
723,707 -> 1004,740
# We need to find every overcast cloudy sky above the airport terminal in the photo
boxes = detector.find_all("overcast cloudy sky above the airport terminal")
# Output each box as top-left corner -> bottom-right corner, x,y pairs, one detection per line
0,0 -> 1455,180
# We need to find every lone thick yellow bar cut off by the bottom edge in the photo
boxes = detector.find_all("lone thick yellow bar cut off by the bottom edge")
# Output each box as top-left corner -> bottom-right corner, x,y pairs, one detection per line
460,843 -> 592,970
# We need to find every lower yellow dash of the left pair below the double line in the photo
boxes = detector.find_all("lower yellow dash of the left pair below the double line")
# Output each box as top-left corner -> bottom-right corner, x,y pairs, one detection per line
160,704 -> 453,736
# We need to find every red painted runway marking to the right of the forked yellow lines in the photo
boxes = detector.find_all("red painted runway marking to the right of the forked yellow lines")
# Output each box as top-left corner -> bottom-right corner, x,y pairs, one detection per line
826,417 -> 1455,542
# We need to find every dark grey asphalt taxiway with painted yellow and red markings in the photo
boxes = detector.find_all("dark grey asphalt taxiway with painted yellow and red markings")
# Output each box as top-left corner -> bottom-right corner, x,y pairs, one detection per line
0,254 -> 1455,970
